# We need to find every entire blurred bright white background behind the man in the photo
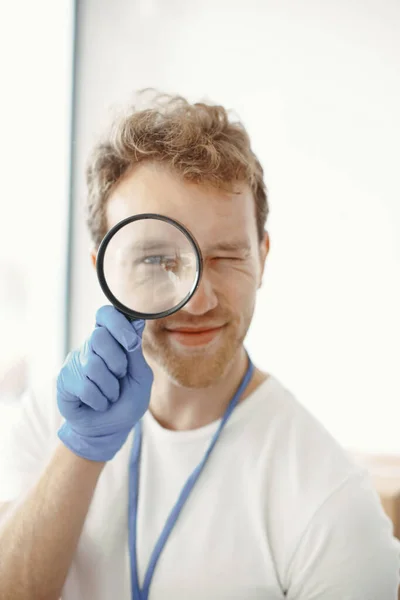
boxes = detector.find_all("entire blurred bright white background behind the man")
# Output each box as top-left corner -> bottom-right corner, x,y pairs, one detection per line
0,0 -> 400,454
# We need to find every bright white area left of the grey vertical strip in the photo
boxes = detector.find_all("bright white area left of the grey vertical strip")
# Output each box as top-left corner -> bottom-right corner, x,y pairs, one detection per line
0,0 -> 74,384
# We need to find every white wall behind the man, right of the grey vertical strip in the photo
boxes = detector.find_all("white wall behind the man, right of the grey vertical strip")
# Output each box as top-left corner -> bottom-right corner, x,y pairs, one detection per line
71,0 -> 400,452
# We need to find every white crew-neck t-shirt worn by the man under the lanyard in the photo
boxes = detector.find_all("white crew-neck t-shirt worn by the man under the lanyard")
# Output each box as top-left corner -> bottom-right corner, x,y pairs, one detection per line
0,376 -> 400,600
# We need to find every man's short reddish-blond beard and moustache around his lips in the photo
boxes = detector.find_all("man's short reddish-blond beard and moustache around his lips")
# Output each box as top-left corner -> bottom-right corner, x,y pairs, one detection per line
143,310 -> 252,388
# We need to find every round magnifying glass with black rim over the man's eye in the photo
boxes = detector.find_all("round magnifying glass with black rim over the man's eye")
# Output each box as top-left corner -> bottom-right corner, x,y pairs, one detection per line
96,213 -> 202,320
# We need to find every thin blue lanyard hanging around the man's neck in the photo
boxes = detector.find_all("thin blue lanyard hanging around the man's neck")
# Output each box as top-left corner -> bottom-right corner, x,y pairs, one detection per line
128,358 -> 254,600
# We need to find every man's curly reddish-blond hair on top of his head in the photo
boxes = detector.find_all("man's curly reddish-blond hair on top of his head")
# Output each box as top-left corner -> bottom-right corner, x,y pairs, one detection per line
86,94 -> 269,247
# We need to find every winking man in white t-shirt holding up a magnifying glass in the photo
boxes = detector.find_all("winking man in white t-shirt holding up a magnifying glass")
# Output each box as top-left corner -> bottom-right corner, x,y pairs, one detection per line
0,98 -> 399,600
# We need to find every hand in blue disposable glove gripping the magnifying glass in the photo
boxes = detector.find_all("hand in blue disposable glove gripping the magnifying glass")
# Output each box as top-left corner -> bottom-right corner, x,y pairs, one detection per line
57,306 -> 153,462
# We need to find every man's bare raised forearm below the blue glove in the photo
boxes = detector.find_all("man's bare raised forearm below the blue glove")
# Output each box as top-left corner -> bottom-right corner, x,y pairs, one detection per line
0,444 -> 105,600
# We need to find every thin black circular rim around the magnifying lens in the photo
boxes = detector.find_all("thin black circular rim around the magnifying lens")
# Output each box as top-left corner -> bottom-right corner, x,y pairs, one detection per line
96,213 -> 203,320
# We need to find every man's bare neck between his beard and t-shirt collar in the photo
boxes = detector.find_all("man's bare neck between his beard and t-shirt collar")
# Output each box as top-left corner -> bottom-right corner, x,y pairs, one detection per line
150,348 -> 267,431
